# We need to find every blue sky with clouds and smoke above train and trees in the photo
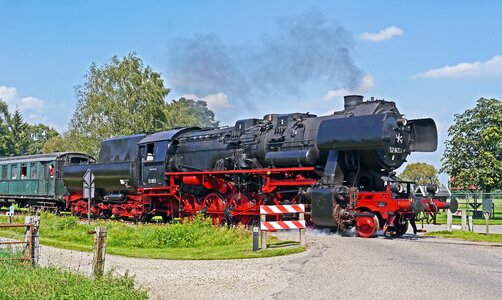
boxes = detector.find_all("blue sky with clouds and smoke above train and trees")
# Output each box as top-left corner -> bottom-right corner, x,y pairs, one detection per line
0,0 -> 502,183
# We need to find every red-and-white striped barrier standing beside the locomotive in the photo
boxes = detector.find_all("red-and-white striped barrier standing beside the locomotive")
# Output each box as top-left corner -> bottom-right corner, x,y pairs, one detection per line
260,204 -> 306,250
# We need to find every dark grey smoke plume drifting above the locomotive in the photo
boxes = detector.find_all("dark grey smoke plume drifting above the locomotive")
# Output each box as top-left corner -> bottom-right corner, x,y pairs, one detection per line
167,12 -> 364,113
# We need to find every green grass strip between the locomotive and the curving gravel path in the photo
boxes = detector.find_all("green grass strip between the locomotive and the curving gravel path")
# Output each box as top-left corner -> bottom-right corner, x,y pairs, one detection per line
0,213 -> 305,260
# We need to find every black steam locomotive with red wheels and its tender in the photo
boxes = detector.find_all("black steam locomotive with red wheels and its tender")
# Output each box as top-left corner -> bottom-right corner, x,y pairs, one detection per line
0,95 -> 456,237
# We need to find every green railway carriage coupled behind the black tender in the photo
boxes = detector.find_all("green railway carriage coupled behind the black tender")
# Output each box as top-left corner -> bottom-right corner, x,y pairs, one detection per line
0,152 -> 95,209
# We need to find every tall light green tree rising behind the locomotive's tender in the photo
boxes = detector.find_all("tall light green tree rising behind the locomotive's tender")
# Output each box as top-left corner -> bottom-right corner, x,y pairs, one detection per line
64,53 -> 169,155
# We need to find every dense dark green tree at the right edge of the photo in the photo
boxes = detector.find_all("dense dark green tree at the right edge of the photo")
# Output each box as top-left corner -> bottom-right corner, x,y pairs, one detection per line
441,98 -> 502,192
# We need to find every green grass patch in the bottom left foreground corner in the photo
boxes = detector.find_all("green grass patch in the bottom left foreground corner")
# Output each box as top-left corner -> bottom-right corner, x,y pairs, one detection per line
0,253 -> 148,299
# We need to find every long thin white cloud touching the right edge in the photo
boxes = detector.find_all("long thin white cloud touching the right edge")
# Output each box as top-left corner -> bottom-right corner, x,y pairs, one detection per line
413,55 -> 502,78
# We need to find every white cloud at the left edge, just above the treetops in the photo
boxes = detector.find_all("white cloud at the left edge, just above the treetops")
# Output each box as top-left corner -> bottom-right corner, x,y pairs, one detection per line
0,85 -> 45,124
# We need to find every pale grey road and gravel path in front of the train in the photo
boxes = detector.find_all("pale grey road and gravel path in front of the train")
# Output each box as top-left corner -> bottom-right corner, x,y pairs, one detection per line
37,231 -> 502,299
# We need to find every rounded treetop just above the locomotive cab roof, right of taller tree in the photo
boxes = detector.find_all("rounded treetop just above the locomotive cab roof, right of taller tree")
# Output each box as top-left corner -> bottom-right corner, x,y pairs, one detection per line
166,97 -> 219,127
